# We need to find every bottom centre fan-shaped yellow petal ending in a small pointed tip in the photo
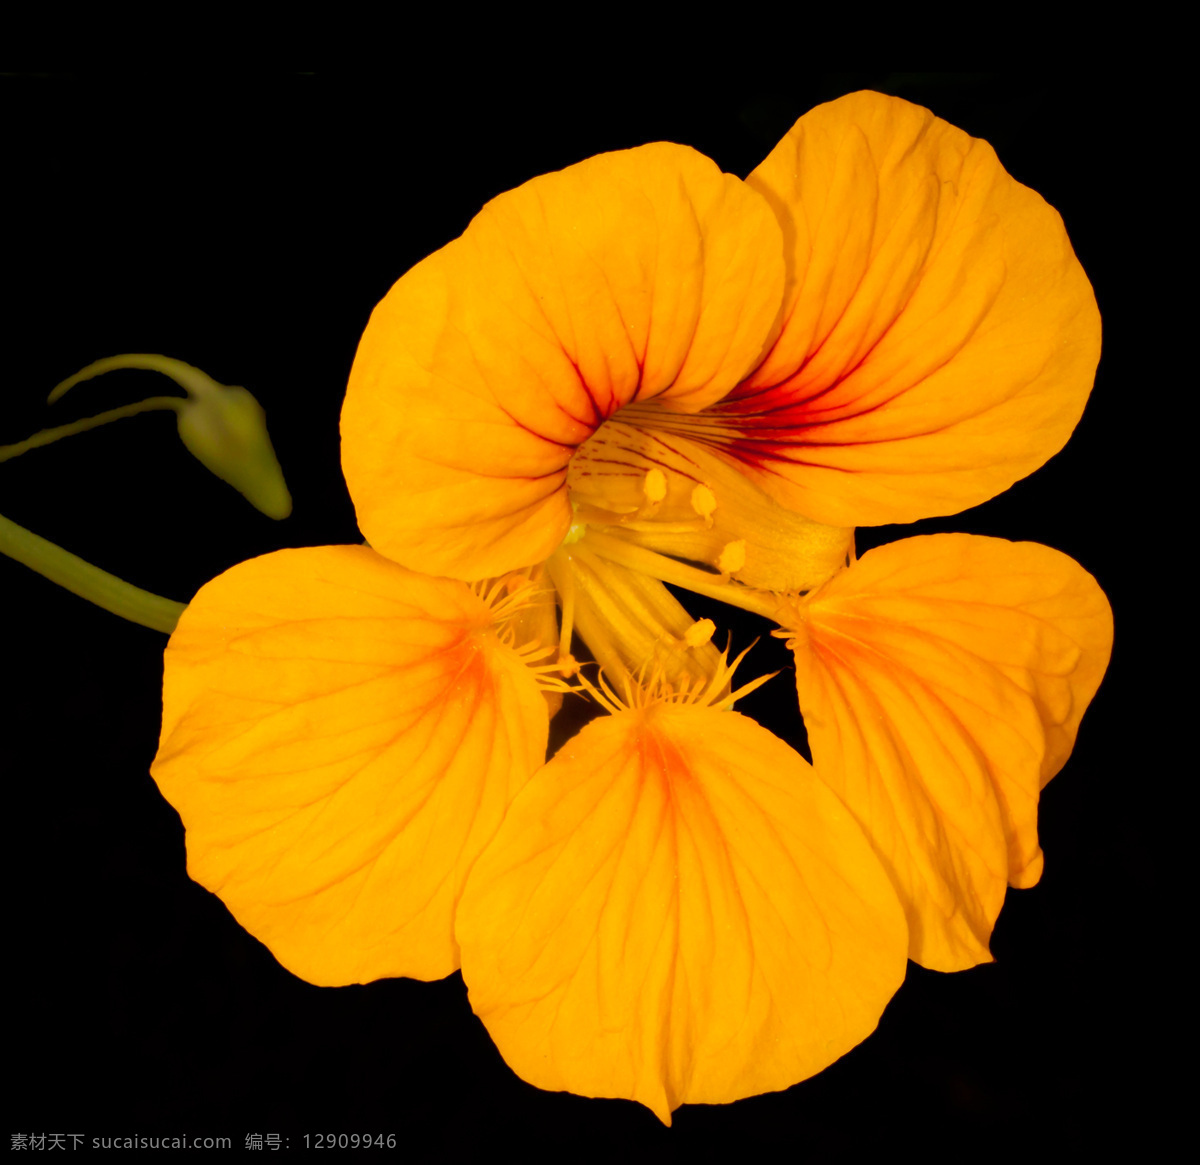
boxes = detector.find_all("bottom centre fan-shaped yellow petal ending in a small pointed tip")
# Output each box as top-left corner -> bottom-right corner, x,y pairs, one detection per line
458,703 -> 907,1122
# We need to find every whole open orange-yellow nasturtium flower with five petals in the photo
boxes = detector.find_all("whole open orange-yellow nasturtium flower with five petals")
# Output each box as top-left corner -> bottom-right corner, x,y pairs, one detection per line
154,92 -> 1111,1121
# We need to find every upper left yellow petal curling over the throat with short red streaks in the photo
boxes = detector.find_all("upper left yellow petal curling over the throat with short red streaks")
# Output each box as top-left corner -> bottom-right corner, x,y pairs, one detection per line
342,143 -> 784,578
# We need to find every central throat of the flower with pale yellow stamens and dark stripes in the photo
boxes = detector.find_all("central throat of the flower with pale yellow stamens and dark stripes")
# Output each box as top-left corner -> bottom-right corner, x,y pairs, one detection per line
511,406 -> 853,705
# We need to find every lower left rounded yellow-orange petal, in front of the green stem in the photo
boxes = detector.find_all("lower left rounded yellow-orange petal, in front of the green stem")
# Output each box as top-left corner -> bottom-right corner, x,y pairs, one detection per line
152,546 -> 547,985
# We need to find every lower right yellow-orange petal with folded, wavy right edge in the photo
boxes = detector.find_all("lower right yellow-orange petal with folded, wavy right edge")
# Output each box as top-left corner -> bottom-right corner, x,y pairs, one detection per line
792,534 -> 1112,971
